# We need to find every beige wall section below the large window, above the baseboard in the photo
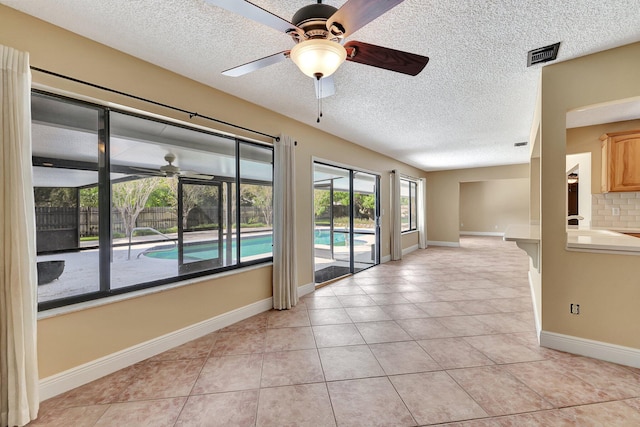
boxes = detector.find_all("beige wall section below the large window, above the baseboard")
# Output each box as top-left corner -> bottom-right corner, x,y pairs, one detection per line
38,266 -> 272,378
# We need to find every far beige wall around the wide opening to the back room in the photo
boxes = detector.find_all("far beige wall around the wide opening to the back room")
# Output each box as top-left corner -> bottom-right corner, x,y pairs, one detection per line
427,164 -> 529,243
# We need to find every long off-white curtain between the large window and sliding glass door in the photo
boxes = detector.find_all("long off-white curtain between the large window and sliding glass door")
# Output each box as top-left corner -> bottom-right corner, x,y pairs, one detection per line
273,135 -> 298,310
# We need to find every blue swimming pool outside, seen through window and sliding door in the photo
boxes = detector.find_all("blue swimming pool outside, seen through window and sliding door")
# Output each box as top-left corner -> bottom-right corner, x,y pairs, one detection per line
143,230 -> 367,262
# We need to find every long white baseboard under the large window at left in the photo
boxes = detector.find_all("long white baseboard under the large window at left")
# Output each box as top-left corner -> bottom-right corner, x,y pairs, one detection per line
40,298 -> 273,401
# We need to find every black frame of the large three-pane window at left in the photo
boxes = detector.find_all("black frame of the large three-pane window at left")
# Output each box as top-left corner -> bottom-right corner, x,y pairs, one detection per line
31,89 -> 274,312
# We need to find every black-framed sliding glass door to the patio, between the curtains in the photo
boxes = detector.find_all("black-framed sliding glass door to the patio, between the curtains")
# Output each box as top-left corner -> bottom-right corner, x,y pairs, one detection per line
314,162 -> 380,283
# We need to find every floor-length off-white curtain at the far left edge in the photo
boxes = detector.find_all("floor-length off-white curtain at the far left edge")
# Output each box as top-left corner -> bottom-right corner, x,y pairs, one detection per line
0,45 -> 39,426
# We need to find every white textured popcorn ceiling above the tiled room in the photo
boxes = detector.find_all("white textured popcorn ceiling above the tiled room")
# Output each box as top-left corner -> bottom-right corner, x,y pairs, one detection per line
5,0 -> 640,170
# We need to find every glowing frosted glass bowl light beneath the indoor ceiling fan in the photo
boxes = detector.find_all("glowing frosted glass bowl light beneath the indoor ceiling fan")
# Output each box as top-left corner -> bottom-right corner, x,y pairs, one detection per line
290,39 -> 347,78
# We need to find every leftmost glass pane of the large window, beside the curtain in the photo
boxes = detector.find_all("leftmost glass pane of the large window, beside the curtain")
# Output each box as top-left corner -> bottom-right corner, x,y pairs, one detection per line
31,95 -> 100,302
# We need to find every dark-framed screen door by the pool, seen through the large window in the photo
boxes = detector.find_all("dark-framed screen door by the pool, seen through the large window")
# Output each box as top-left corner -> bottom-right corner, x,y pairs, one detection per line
178,178 -> 224,274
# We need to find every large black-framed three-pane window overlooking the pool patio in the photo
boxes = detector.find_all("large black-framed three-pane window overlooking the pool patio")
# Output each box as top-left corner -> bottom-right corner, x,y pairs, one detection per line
32,91 -> 273,309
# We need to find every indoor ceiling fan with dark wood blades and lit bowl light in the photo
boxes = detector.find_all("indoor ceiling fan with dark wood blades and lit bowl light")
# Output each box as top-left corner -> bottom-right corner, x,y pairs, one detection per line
205,0 -> 429,99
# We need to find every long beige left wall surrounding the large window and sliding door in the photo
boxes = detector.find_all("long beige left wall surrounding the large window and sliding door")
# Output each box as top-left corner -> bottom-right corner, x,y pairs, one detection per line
0,5 -> 424,378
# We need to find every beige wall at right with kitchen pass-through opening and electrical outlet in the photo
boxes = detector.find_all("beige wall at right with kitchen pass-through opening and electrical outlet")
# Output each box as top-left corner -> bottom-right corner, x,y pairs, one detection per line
541,43 -> 640,348
